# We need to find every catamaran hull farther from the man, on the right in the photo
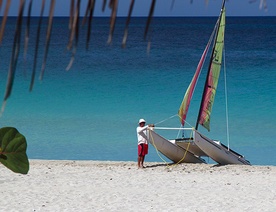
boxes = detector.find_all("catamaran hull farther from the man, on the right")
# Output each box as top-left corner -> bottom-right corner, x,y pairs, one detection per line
194,130 -> 250,165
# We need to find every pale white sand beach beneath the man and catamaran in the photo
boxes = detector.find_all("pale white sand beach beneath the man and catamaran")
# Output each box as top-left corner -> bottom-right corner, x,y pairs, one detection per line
0,160 -> 276,212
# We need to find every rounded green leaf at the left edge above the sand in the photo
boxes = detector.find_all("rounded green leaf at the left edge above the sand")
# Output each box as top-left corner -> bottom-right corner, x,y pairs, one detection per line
0,127 -> 29,174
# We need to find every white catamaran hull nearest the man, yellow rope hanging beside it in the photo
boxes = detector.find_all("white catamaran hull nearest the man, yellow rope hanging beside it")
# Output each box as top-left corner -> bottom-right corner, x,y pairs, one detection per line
148,129 -> 206,163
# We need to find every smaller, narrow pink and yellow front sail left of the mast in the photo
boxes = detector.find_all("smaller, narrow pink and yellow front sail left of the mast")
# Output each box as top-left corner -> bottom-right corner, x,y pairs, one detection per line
178,38 -> 213,126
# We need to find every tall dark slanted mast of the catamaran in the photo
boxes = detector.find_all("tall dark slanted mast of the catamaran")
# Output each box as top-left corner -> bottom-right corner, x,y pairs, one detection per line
195,0 -> 225,130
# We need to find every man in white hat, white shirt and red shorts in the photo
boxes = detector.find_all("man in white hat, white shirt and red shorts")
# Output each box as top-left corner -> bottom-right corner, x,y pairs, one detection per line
137,119 -> 154,168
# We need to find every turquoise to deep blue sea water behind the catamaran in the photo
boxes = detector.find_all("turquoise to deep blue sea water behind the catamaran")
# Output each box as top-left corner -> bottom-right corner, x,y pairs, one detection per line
0,17 -> 276,165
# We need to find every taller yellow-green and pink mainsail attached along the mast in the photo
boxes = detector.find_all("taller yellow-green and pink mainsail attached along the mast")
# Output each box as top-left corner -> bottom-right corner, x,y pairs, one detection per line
196,6 -> 225,131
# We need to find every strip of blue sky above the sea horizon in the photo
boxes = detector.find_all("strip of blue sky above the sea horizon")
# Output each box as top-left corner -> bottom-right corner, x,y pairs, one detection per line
0,0 -> 276,16
